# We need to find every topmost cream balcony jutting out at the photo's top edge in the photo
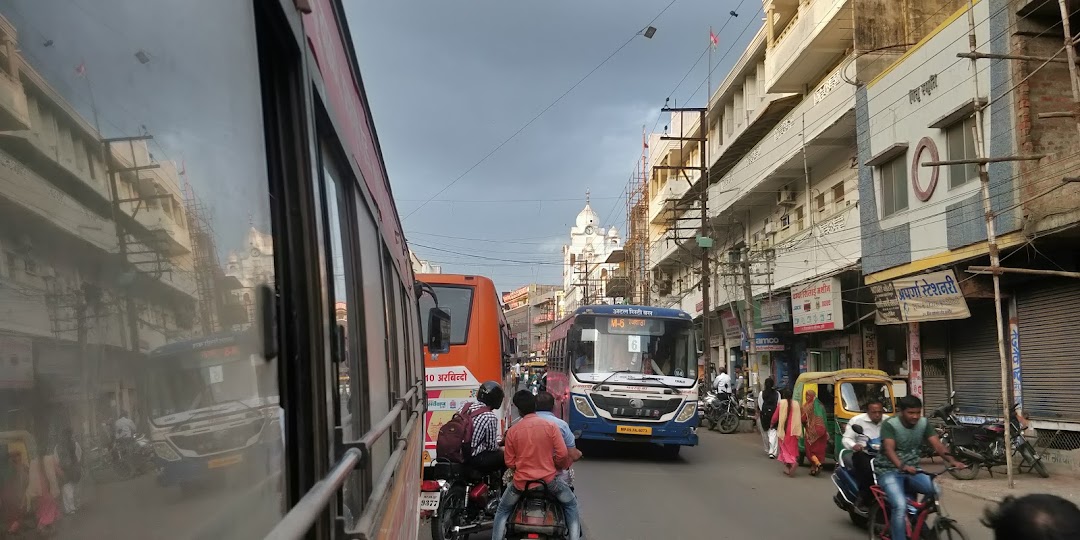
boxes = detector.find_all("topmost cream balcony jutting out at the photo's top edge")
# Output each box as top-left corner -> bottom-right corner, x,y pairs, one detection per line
765,0 -> 854,94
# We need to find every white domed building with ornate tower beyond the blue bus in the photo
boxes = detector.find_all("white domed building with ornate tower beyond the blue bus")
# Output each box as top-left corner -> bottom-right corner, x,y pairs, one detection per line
561,194 -> 622,313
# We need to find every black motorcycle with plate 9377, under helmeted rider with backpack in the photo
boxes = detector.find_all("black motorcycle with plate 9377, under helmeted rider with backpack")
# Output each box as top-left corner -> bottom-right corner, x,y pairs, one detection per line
420,459 -> 509,540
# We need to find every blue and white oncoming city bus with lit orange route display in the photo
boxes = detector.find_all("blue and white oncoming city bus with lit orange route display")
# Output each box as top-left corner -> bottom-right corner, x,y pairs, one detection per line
548,306 -> 699,456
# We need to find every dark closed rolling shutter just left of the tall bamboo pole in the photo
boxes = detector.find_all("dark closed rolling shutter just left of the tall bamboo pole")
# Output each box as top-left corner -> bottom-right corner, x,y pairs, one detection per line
948,300 -> 1001,415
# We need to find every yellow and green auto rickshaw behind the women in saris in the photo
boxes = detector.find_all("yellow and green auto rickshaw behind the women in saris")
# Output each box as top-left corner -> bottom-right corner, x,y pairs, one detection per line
792,369 -> 895,465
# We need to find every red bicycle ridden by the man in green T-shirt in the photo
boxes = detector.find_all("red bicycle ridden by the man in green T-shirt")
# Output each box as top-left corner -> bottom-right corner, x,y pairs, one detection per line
866,468 -> 968,540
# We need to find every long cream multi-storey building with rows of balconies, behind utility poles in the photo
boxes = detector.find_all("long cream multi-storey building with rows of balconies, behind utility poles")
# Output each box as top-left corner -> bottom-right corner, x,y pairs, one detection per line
650,0 -> 959,384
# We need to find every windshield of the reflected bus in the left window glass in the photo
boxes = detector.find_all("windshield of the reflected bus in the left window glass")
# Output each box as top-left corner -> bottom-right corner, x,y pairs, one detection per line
148,345 -> 272,426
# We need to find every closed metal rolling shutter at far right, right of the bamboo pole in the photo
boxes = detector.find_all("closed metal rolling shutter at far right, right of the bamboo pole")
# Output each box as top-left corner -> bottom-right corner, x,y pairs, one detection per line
1016,281 -> 1080,421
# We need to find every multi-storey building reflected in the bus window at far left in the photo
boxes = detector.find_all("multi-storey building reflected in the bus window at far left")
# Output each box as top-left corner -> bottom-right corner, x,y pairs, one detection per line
0,12 -> 200,432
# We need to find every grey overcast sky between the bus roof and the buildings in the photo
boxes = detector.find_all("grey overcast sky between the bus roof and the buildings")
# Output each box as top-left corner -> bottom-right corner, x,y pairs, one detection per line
346,0 -> 761,291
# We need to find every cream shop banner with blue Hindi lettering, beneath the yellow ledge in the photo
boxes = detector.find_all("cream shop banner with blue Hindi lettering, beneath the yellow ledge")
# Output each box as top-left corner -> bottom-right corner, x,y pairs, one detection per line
870,270 -> 971,324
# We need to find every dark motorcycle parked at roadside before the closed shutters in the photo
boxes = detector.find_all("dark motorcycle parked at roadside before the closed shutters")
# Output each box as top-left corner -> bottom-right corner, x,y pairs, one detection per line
933,397 -> 1050,480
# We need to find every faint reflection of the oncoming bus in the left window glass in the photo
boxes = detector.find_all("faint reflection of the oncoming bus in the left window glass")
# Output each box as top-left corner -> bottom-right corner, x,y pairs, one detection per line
148,332 -> 282,487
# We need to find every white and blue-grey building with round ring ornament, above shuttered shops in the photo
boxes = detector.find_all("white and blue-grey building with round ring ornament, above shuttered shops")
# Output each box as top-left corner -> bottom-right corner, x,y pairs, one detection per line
856,0 -> 1080,468
